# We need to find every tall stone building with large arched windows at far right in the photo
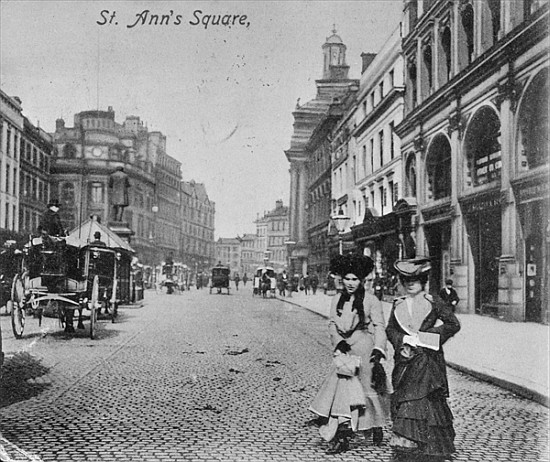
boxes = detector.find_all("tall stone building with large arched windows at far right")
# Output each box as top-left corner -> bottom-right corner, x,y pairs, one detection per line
396,0 -> 550,323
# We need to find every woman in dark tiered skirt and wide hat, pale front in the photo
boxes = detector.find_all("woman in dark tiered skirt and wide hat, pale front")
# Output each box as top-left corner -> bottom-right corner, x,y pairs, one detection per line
386,258 -> 460,461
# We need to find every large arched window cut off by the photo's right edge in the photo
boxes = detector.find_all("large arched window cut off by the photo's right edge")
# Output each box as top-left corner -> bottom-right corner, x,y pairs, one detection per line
519,68 -> 549,170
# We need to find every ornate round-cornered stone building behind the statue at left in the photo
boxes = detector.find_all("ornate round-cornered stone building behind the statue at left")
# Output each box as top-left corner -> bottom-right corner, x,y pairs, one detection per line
51,107 -> 156,256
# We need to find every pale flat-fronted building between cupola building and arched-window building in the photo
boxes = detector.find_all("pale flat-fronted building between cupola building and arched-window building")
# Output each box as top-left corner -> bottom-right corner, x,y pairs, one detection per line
348,27 -> 414,277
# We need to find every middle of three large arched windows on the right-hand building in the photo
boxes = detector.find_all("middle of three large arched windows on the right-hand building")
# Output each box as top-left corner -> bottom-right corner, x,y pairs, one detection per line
465,107 -> 502,186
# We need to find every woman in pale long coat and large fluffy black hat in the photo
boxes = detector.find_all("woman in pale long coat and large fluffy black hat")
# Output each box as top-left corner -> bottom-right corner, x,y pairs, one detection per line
310,255 -> 390,453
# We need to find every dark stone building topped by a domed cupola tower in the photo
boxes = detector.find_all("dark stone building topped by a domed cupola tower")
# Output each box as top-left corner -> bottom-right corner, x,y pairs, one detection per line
285,31 -> 359,274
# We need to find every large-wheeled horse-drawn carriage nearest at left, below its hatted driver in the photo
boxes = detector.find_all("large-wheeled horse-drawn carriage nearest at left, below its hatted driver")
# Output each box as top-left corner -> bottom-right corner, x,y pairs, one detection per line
10,235 -> 116,339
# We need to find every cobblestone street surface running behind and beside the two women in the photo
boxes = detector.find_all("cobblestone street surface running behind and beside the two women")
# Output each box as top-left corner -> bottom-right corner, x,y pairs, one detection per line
0,286 -> 548,462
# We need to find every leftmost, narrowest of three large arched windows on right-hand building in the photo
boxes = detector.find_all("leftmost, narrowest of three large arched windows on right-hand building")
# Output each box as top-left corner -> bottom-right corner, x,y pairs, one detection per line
426,135 -> 452,201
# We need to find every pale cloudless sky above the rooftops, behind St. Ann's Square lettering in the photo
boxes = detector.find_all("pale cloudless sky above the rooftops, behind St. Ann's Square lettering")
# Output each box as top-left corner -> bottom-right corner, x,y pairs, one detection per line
0,0 -> 403,239
